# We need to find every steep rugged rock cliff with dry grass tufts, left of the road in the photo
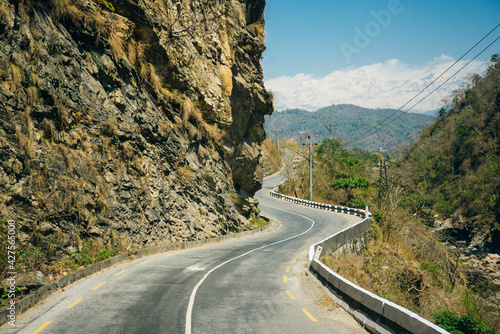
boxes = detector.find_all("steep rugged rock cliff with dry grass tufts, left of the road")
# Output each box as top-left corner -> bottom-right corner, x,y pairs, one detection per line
0,0 -> 272,262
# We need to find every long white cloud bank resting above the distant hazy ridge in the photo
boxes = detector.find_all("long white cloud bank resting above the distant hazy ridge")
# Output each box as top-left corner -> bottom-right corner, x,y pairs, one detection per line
265,55 -> 487,111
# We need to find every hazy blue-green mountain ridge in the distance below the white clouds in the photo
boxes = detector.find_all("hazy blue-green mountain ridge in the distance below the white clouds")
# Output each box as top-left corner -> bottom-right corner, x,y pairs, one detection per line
264,104 -> 434,152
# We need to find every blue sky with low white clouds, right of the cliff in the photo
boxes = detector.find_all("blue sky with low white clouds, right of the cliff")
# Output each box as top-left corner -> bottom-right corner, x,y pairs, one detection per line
263,0 -> 500,110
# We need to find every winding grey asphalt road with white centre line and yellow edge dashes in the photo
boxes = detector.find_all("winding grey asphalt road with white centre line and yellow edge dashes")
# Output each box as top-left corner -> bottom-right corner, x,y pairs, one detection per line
0,175 -> 365,334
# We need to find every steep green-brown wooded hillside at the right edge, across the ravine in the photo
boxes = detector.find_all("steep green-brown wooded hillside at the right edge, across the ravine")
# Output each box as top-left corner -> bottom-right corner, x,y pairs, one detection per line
399,55 -> 500,253
